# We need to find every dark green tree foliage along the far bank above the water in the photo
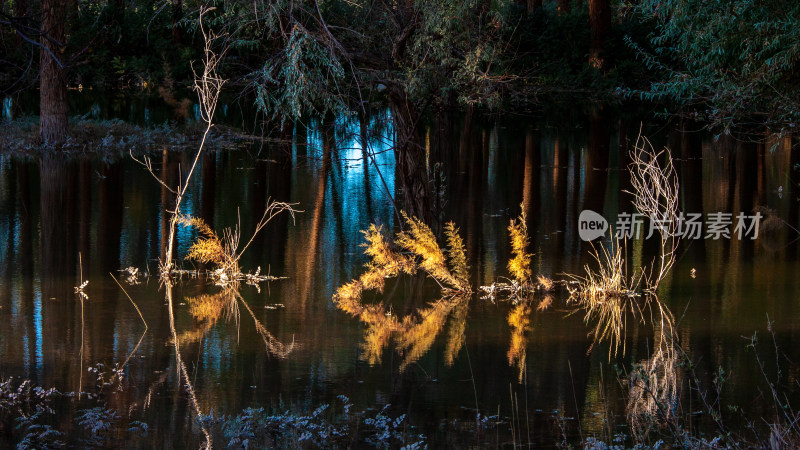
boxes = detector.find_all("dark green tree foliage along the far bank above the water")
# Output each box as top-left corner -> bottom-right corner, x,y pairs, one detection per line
0,0 -> 800,148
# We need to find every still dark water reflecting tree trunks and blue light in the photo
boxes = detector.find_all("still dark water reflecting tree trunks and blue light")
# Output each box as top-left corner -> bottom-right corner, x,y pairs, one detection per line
0,96 -> 800,447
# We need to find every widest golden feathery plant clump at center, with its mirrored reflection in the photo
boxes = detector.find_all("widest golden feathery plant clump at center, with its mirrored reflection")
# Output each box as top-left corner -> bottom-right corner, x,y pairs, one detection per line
333,213 -> 471,370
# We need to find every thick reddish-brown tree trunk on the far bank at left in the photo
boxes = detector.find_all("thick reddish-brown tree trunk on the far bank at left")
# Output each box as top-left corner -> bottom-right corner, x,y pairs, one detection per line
39,0 -> 67,146
